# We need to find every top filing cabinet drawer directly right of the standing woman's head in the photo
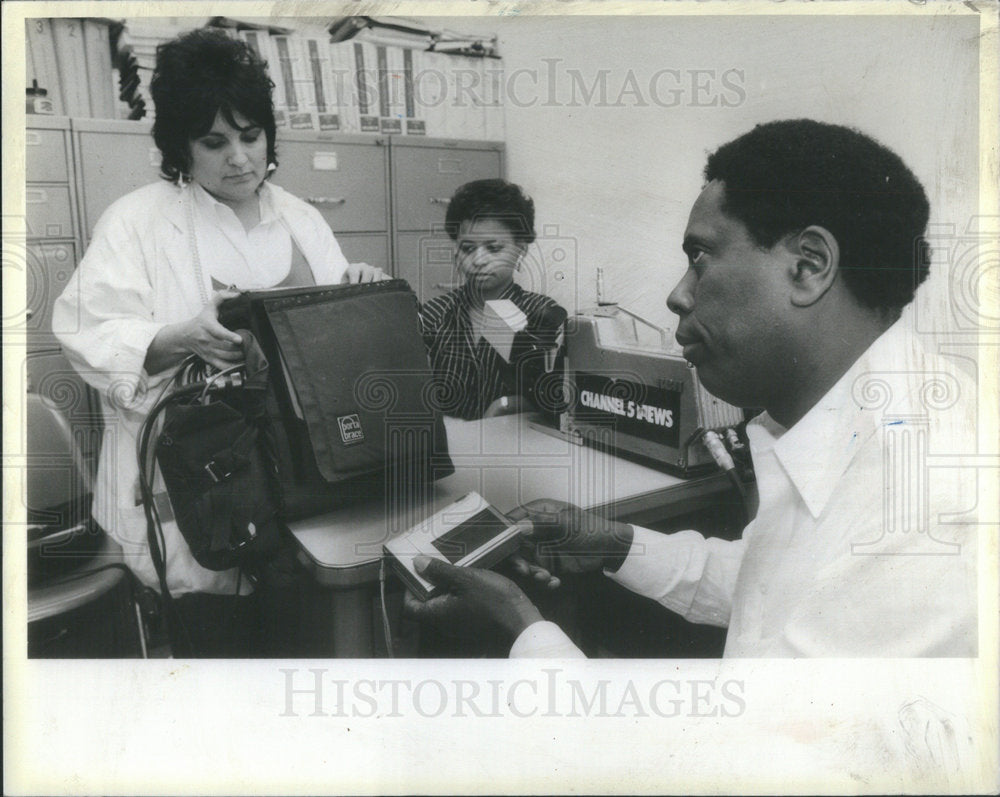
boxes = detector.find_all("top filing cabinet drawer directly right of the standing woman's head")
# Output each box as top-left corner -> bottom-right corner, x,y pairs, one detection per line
272,141 -> 389,233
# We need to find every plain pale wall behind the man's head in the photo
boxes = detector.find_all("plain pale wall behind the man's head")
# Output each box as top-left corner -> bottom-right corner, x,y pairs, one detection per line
468,15 -> 978,350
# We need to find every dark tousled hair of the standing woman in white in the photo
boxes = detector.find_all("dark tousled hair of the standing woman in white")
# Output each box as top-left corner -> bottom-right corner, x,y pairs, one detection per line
150,28 -> 278,180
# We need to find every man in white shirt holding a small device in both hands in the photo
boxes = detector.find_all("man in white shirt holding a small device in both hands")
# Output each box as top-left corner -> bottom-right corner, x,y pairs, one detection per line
407,120 -> 977,657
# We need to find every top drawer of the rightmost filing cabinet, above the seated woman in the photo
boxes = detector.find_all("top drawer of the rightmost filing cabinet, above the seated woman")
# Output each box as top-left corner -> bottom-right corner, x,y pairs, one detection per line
392,146 -> 503,231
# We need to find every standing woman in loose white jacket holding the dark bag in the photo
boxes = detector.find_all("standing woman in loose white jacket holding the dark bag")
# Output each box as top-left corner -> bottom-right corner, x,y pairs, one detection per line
54,29 -> 383,656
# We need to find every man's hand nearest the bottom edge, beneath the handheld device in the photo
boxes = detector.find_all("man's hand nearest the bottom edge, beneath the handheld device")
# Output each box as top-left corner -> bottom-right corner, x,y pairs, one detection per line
403,556 -> 542,642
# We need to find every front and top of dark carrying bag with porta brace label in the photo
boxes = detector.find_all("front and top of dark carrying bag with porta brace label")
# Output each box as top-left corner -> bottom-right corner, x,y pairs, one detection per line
219,280 -> 454,519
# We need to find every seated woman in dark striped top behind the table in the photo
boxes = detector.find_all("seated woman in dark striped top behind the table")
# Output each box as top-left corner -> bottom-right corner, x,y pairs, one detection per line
420,179 -> 566,420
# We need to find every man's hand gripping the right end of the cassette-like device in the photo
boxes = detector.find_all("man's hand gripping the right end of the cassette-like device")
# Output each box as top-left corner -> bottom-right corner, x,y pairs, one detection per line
508,499 -> 632,586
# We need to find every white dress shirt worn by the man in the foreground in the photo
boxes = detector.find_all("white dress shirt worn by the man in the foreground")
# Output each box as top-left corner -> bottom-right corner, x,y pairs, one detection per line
511,322 -> 977,657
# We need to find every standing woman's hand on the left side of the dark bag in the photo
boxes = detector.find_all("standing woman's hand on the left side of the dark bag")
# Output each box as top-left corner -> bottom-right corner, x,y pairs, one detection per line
144,291 -> 243,374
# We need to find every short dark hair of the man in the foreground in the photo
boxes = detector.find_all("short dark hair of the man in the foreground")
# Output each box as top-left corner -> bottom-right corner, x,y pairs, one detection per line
705,119 -> 929,313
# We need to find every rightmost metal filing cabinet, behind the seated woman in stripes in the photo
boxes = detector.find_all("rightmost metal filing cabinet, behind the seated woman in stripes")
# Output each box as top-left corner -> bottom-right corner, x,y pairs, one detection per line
390,136 -> 504,302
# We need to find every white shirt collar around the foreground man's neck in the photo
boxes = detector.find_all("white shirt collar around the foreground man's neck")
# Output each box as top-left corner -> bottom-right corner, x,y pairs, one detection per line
747,321 -> 915,518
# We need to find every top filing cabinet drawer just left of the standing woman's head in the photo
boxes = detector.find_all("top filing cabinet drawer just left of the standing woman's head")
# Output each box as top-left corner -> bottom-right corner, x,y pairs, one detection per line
77,123 -> 161,241
